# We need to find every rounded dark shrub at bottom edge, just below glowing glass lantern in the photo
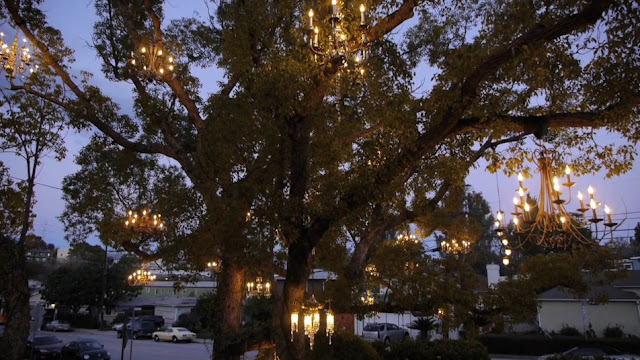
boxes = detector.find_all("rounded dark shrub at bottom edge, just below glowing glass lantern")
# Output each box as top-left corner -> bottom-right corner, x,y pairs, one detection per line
310,333 -> 382,360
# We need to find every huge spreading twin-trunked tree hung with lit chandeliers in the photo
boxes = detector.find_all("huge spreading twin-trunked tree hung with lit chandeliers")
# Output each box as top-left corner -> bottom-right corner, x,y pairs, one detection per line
2,0 -> 640,360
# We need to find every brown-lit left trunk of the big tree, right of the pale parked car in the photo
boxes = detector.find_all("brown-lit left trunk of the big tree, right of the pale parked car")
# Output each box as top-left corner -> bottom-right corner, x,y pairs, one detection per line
213,259 -> 247,360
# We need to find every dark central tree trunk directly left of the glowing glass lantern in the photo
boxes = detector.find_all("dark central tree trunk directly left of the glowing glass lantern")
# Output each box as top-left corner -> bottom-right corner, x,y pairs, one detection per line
276,241 -> 312,360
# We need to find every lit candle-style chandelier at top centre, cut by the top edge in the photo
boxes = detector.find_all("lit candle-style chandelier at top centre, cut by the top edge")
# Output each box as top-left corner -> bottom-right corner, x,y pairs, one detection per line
306,0 -> 369,69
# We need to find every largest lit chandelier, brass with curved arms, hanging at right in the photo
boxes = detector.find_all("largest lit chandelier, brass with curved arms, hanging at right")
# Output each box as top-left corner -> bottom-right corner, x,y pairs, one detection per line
495,150 -> 618,250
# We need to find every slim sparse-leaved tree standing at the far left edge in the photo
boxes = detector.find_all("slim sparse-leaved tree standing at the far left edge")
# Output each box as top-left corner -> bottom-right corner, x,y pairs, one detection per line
0,74 -> 66,360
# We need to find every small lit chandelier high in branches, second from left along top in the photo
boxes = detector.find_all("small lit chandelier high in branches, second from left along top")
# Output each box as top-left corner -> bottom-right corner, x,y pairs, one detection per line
129,42 -> 174,80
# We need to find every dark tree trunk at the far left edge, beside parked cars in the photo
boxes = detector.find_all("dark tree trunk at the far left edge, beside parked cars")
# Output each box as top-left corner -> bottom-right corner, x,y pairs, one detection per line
0,236 -> 30,360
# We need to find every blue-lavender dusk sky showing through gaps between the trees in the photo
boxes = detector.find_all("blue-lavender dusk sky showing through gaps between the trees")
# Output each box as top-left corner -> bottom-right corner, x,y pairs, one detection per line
0,0 -> 640,248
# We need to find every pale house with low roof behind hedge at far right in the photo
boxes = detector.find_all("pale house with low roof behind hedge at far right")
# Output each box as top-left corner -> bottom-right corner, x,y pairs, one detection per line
538,270 -> 640,337
